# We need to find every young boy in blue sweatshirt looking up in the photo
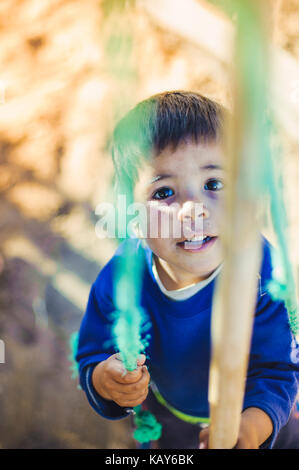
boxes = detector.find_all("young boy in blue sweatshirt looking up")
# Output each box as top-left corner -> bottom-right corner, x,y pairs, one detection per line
76,92 -> 299,449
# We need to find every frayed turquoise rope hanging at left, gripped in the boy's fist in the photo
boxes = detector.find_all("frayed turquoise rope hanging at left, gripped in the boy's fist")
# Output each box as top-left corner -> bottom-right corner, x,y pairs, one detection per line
103,0 -> 161,442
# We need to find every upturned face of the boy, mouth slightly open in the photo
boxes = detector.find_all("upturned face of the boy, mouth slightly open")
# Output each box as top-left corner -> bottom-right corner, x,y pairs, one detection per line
135,142 -> 225,286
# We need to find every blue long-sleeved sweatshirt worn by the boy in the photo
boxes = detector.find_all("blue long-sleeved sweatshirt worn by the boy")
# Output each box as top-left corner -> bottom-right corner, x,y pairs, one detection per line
76,237 -> 299,447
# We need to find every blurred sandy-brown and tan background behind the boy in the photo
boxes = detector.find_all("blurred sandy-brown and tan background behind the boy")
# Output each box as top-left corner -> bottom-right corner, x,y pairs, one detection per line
0,0 -> 299,449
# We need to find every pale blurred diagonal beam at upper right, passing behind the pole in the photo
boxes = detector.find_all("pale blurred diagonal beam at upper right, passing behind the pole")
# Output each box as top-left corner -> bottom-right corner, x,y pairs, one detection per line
138,0 -> 299,142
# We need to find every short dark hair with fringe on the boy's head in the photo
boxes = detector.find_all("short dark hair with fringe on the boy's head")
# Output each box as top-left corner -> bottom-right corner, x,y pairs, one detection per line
112,91 -> 225,190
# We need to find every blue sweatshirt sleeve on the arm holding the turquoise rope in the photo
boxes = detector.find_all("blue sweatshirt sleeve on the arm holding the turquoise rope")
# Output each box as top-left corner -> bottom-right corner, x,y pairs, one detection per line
76,270 -> 131,420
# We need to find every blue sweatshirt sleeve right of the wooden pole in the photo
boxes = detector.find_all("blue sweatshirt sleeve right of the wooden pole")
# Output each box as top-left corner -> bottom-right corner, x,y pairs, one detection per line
243,291 -> 299,448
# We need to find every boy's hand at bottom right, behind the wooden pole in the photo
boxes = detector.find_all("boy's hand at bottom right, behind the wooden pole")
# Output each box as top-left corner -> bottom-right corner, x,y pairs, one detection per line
199,407 -> 273,449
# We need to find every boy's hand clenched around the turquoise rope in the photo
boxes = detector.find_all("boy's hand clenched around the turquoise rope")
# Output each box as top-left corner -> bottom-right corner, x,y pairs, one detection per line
92,354 -> 150,407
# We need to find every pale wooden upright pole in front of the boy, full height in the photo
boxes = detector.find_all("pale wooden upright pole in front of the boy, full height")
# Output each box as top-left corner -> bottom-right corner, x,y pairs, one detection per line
209,0 -> 272,449
